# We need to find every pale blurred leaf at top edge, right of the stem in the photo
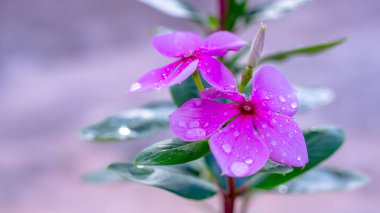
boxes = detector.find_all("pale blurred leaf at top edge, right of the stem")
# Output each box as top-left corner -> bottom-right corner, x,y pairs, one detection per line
246,0 -> 311,22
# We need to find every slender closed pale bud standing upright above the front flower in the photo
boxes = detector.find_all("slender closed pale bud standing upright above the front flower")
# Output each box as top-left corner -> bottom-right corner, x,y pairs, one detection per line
248,23 -> 267,68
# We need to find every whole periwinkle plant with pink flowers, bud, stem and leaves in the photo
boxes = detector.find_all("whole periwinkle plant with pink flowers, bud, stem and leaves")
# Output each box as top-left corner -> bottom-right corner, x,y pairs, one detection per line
81,0 -> 368,213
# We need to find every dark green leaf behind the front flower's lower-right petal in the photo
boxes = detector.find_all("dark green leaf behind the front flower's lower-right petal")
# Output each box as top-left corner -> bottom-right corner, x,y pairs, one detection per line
253,127 -> 344,190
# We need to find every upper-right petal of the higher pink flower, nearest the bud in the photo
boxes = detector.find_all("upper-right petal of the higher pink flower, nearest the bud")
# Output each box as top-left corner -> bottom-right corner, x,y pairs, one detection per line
205,31 -> 247,56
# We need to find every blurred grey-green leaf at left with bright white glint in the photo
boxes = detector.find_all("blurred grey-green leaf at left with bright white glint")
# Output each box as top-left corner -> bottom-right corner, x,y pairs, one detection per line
80,102 -> 176,142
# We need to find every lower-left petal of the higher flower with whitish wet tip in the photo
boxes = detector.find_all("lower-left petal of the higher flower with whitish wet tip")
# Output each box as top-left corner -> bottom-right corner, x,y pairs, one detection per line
129,60 -> 182,92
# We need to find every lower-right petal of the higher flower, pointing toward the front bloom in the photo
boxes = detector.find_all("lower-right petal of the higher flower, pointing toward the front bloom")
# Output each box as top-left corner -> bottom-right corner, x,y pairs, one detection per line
198,56 -> 236,91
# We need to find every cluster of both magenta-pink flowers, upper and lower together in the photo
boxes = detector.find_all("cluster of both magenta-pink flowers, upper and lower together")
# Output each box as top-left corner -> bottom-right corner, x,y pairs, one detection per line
130,31 -> 308,177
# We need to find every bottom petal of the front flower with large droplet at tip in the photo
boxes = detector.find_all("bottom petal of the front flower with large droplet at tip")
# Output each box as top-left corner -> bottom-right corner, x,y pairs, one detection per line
209,115 -> 269,177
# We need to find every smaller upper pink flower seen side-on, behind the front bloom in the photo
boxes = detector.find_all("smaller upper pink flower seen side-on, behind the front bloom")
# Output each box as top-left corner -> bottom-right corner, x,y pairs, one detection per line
129,31 -> 246,92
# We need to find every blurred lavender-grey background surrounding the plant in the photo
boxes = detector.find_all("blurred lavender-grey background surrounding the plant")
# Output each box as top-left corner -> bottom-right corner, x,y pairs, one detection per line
0,0 -> 380,213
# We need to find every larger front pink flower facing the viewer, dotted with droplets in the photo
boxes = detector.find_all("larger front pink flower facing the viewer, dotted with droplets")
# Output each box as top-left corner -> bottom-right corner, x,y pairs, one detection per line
169,66 -> 308,177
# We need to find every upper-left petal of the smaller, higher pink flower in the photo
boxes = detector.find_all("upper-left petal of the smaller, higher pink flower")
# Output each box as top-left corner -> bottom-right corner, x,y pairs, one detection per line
152,32 -> 204,57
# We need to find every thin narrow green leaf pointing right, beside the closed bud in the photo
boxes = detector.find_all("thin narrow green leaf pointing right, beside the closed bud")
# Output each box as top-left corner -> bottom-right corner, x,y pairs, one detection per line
260,38 -> 346,63
